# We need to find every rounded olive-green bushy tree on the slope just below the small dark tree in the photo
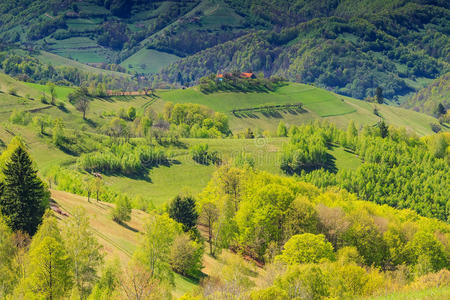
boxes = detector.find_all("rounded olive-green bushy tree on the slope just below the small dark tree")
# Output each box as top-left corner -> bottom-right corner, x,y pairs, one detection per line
170,234 -> 203,277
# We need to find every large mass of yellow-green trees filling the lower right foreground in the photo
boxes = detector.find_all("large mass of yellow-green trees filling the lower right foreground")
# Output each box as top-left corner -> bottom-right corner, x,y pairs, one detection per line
192,165 -> 450,299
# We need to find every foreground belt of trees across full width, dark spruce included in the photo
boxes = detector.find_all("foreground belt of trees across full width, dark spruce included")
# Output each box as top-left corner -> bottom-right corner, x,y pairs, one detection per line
0,139 -> 450,299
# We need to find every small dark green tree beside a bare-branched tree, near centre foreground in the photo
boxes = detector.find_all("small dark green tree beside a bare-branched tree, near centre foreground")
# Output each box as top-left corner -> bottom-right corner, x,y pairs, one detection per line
169,195 -> 198,231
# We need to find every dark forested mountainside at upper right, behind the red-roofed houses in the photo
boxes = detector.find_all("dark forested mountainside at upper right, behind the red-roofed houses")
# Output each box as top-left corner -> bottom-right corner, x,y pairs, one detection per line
156,1 -> 450,98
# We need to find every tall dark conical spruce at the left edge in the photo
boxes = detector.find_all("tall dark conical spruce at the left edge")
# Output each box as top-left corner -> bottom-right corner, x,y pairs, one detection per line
0,146 -> 47,235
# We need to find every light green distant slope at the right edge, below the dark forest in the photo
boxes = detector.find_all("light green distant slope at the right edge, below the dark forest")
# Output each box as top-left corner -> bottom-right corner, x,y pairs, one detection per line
405,73 -> 450,115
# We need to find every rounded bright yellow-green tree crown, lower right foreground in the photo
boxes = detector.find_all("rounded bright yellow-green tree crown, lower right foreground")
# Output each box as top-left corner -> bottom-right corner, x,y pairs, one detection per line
276,233 -> 334,265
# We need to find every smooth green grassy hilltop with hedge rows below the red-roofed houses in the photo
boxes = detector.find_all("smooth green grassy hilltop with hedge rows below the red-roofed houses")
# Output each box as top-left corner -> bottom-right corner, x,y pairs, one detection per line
154,83 -> 438,135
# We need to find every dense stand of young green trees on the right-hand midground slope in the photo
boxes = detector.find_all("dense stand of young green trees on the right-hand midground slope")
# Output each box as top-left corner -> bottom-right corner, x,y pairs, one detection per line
281,121 -> 450,220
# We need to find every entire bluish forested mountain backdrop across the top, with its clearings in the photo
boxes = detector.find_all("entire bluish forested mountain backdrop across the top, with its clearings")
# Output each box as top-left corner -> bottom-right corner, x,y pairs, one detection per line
0,0 -> 450,100
